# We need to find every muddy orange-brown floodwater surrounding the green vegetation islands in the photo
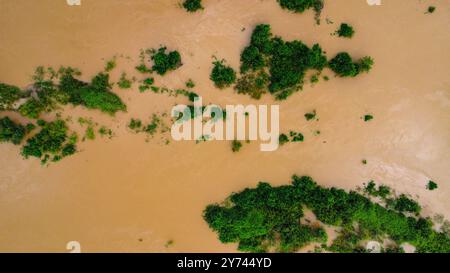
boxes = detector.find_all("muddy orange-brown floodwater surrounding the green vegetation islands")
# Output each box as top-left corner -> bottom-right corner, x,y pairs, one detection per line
0,0 -> 450,252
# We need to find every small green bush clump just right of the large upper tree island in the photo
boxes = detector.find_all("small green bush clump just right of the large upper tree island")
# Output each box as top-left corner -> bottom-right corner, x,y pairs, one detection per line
328,52 -> 374,77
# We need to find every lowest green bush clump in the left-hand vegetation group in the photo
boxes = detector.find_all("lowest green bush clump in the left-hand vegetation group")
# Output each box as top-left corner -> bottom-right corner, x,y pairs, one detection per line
22,120 -> 76,164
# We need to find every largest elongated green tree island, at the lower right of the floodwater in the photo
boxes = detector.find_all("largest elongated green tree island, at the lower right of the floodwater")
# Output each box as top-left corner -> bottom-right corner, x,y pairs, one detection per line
203,176 -> 450,253
